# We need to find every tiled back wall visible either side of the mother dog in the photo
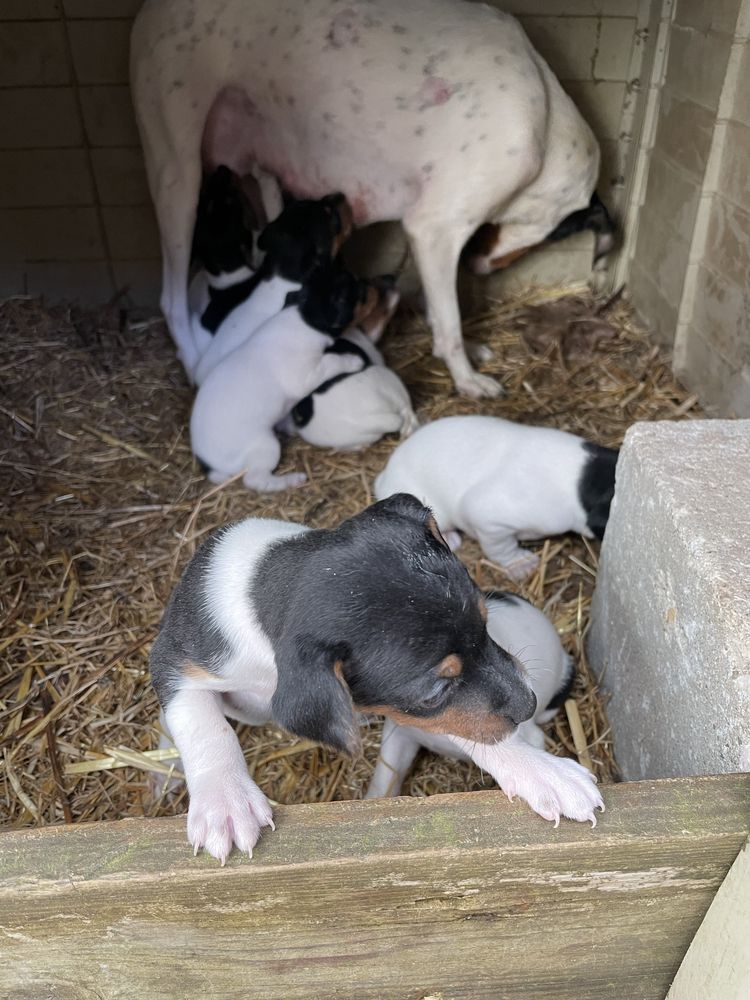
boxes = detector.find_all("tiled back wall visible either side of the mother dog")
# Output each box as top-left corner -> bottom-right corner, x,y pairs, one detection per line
0,0 -> 650,304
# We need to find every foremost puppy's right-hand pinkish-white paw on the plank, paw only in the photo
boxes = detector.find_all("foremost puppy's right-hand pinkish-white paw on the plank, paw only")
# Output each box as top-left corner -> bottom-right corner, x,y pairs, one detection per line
501,753 -> 604,826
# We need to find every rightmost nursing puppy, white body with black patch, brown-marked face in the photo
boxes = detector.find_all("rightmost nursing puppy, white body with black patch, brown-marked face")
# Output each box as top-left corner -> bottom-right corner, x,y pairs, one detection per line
282,279 -> 419,450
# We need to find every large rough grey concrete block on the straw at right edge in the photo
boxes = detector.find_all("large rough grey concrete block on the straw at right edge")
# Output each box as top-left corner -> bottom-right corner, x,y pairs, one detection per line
588,420 -> 750,779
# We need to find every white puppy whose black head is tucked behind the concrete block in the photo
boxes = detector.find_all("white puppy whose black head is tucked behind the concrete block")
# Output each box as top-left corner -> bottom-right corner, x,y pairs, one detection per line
375,416 -> 618,580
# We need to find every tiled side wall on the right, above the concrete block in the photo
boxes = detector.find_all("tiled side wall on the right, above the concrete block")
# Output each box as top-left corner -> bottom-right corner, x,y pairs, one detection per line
627,0 -> 750,416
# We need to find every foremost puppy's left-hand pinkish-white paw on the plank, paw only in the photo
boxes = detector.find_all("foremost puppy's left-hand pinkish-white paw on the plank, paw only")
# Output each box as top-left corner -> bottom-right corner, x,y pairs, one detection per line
188,775 -> 274,865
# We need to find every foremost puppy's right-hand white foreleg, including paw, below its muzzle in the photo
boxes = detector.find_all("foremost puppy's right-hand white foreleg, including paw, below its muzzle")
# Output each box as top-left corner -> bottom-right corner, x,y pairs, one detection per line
449,732 -> 604,826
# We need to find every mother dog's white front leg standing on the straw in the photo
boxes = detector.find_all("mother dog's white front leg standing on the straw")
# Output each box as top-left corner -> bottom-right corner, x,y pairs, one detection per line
404,217 -> 502,399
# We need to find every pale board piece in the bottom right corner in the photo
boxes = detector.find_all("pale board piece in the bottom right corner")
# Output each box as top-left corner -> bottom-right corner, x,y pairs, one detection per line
667,828 -> 750,1000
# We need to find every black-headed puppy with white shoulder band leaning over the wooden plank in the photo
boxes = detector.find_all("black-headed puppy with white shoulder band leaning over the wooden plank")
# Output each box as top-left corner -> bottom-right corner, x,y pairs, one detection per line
151,495 -> 536,864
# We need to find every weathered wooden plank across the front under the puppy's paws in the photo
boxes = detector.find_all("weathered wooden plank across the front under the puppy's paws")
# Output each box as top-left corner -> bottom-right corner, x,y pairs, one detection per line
0,775 -> 750,1000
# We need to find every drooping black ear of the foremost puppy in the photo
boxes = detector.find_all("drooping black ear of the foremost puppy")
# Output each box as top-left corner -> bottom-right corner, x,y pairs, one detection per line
271,638 -> 361,756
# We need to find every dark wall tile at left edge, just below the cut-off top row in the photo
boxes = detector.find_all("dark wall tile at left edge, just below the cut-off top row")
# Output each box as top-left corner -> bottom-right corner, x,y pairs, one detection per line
0,21 -> 70,87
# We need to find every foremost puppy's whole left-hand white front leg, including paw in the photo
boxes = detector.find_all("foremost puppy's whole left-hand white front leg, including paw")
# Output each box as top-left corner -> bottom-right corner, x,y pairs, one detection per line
164,689 -> 273,865
